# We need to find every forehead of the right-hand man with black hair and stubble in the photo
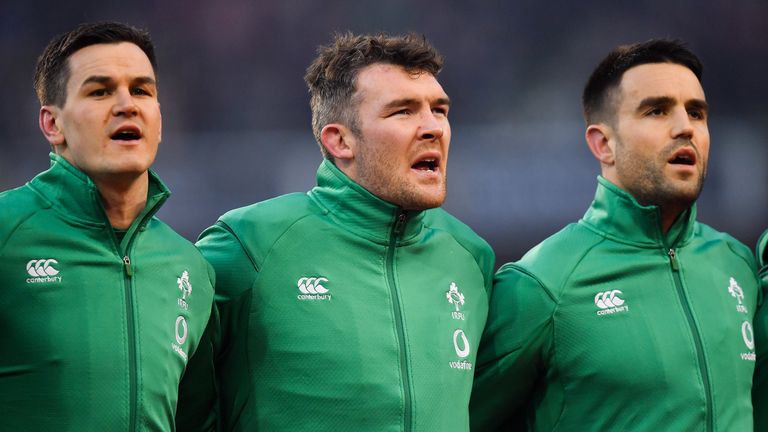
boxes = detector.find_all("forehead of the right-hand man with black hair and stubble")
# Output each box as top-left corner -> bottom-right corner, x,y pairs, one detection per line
619,63 -> 704,103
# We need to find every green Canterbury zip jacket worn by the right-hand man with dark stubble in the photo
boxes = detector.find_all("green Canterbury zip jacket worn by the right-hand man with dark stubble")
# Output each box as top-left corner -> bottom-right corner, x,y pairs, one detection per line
470,177 -> 758,432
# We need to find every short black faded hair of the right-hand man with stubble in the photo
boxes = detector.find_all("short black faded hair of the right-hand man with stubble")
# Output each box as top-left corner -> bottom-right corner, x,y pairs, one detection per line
582,39 -> 703,124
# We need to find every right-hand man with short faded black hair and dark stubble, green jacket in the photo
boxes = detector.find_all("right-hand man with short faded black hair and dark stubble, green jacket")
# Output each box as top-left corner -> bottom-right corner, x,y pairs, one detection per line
470,39 -> 758,431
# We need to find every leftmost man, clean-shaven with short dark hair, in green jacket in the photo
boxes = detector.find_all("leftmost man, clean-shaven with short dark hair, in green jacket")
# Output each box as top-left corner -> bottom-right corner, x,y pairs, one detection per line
0,22 -> 213,431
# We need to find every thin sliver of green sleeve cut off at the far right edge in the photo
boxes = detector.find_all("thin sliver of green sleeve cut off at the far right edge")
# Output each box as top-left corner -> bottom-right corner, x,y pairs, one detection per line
752,231 -> 768,431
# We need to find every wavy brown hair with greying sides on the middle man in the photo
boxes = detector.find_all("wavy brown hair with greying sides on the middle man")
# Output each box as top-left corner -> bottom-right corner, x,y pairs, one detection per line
304,32 -> 443,159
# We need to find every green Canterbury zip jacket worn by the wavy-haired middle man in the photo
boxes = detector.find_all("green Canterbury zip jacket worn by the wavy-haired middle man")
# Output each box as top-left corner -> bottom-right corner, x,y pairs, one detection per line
192,161 -> 494,432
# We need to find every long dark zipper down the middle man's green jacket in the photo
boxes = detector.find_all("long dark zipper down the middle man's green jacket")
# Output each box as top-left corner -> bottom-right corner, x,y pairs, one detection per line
387,210 -> 411,431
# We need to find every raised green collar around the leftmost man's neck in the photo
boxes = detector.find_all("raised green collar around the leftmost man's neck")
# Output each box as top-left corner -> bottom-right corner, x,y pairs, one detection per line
29,153 -> 171,231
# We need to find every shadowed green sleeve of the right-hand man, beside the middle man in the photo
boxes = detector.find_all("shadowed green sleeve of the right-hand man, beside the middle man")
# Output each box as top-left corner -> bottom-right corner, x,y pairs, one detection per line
469,264 -> 555,431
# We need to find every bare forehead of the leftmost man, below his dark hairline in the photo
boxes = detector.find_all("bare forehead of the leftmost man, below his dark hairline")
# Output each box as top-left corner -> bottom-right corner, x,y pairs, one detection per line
67,42 -> 155,87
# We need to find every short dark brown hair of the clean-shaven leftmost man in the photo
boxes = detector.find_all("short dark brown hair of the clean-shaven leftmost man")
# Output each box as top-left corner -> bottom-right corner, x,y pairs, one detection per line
35,22 -> 157,106
